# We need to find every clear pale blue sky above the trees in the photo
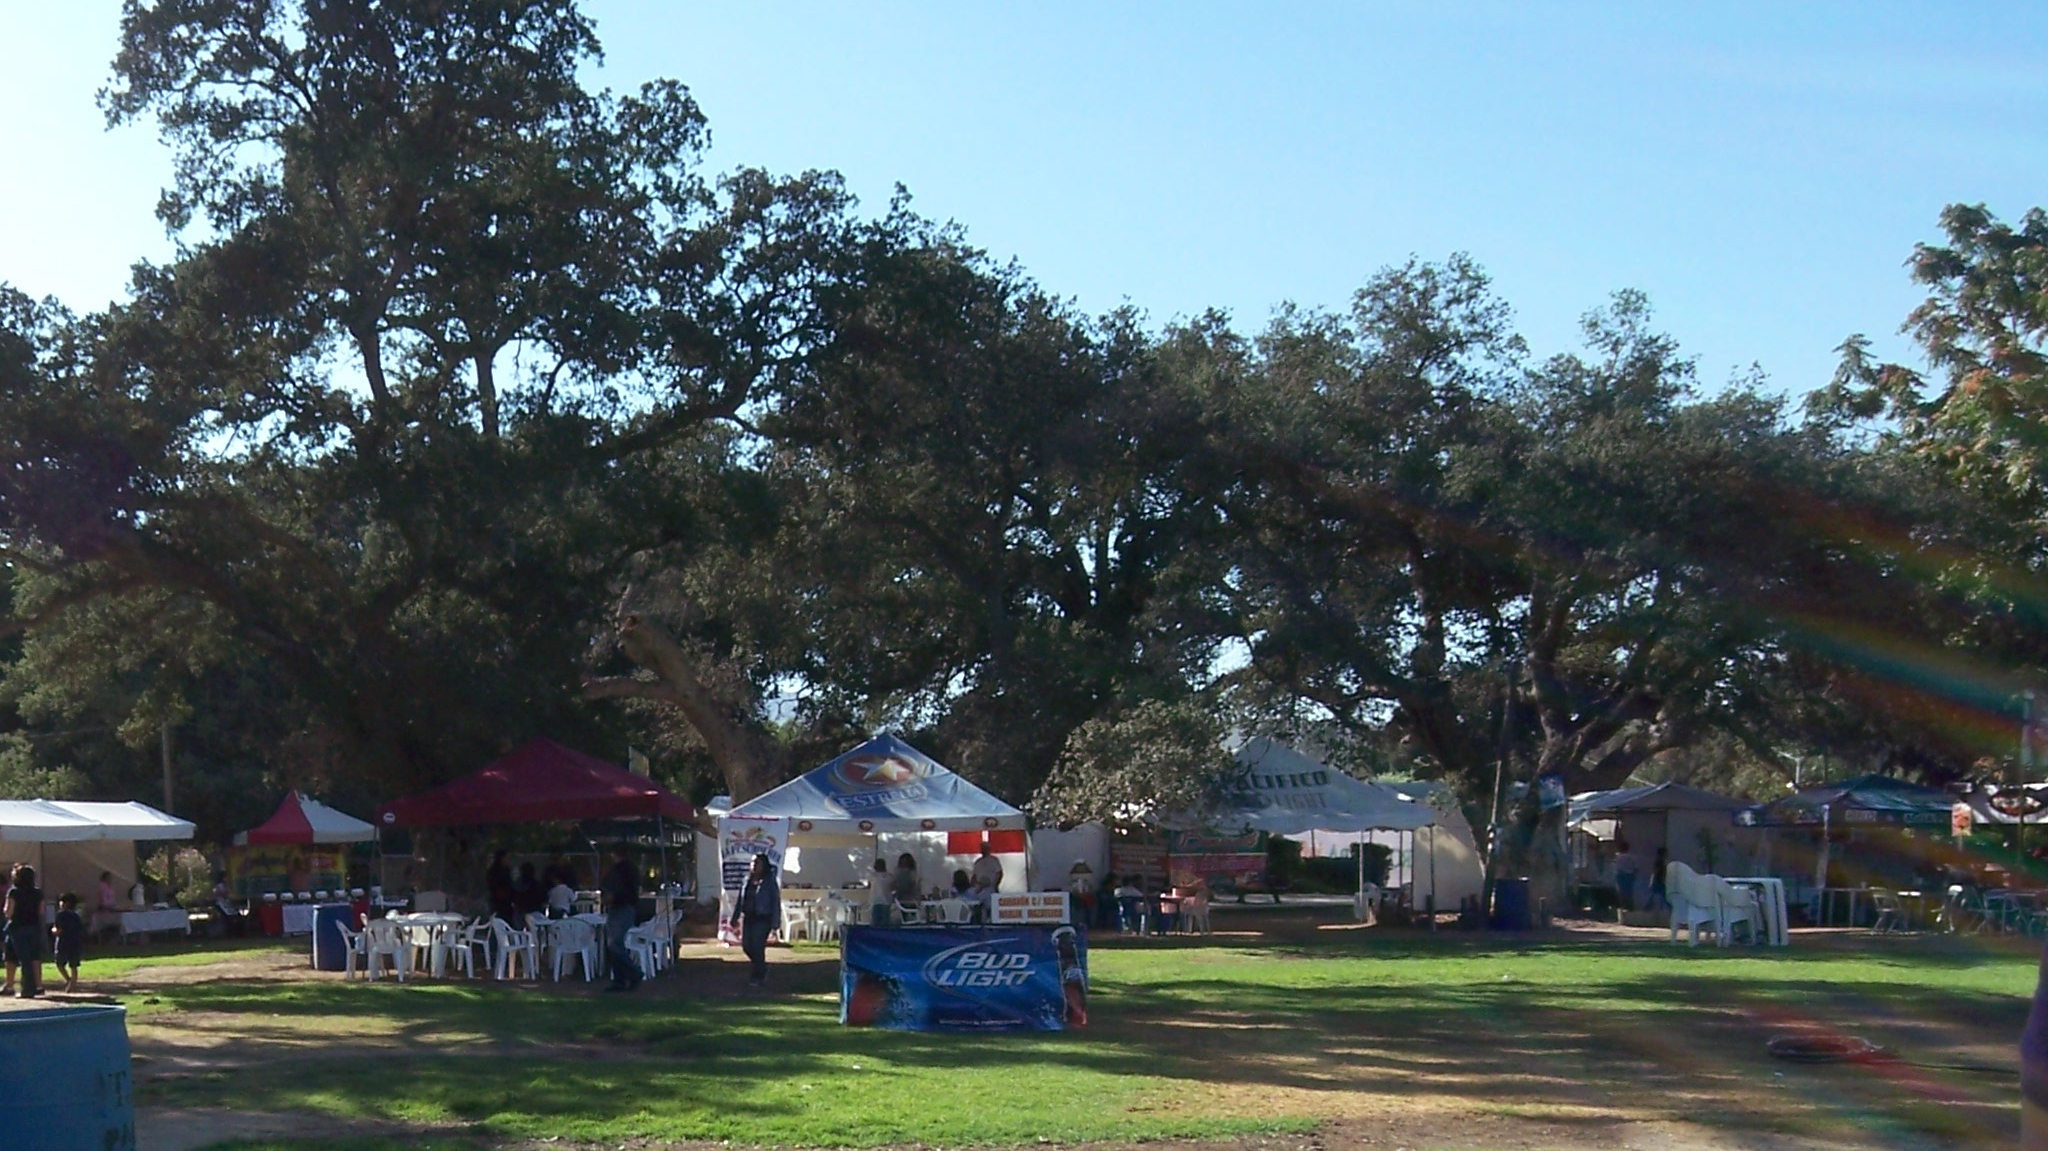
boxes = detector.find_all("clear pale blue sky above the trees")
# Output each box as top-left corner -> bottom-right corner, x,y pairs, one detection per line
0,0 -> 2048,391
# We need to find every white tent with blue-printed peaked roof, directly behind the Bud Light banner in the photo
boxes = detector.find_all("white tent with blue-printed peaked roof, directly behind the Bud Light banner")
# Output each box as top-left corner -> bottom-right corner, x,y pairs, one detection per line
698,735 -> 1030,901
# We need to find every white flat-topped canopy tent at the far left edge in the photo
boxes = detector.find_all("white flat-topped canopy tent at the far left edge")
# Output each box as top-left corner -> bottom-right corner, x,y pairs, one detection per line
0,799 -> 193,907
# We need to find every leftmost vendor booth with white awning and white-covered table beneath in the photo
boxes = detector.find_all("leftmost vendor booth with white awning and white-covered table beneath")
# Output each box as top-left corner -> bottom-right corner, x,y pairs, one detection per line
0,799 -> 193,936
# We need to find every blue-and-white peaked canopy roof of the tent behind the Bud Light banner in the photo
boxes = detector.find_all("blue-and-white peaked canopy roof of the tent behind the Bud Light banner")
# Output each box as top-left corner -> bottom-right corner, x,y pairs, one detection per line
725,735 -> 1026,834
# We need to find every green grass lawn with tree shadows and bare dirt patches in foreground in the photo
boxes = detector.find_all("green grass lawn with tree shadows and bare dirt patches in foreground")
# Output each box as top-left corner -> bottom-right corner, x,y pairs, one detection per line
119,932 -> 2034,1149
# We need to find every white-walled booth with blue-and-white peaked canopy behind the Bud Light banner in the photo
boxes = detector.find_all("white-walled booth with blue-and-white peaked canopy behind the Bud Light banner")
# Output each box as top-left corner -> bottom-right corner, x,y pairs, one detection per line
696,735 -> 1030,933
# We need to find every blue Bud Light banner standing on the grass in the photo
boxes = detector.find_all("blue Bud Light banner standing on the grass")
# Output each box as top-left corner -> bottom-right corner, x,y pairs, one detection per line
840,928 -> 1087,1030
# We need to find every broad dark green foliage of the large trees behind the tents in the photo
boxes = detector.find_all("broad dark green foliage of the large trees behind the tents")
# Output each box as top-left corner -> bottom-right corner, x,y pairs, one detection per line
0,0 -> 2048,842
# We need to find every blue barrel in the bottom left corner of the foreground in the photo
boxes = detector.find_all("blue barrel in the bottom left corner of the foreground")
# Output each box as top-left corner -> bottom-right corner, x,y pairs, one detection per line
0,1008 -> 135,1151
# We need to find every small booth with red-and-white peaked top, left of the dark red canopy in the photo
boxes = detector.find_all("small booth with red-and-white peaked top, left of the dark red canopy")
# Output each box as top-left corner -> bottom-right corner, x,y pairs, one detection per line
227,793 -> 377,936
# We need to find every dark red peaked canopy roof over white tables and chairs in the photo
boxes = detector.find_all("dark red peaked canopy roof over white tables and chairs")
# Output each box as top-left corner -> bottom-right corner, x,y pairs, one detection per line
377,739 -> 696,827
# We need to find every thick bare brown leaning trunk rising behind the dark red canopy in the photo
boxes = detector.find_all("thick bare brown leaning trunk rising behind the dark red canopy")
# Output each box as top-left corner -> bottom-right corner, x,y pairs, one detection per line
584,614 -> 786,803
